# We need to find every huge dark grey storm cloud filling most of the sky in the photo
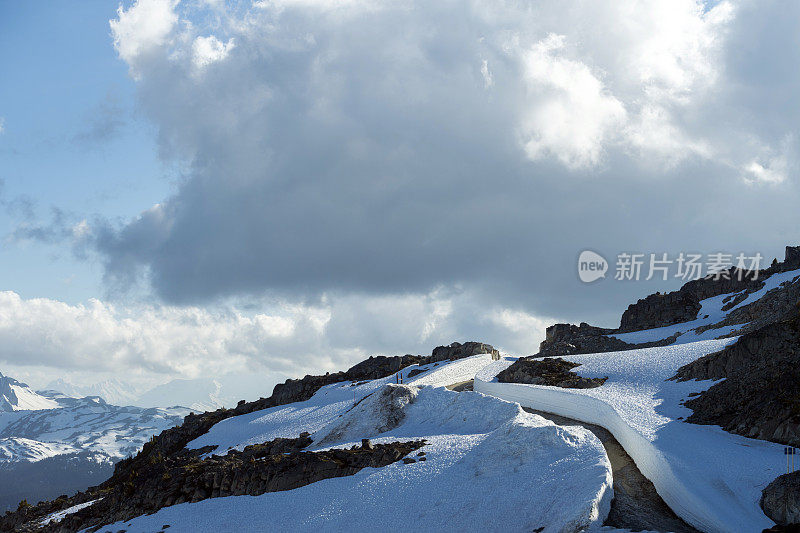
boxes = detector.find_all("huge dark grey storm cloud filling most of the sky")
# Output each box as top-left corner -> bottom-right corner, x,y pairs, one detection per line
94,2 -> 800,320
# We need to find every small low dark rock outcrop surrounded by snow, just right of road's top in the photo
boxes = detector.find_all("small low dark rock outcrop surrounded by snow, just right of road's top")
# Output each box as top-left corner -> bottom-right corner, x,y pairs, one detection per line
497,357 -> 608,389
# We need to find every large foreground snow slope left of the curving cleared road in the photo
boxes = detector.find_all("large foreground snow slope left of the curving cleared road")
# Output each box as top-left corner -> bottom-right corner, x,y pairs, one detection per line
100,378 -> 612,532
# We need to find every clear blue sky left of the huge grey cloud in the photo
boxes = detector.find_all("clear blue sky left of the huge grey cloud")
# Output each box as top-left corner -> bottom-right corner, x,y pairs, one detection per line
0,1 -> 170,303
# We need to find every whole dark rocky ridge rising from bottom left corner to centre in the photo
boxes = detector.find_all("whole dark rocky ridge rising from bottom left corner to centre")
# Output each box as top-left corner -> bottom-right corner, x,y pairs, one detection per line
0,342 -> 499,531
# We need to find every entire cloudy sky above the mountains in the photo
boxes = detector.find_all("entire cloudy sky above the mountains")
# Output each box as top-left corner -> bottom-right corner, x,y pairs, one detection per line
0,0 -> 800,397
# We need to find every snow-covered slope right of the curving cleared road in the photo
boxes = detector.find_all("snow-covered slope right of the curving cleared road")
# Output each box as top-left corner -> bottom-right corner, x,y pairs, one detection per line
475,339 -> 783,532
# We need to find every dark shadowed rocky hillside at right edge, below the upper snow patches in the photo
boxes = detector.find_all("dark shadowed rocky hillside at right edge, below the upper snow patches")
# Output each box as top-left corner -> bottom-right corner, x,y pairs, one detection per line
674,318 -> 800,446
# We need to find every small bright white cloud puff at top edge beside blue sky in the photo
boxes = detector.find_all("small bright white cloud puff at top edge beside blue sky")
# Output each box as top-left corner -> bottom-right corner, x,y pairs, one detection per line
109,0 -> 178,75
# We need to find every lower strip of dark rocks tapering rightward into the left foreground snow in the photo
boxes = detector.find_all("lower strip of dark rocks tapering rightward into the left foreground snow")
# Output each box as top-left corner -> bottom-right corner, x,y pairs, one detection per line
0,433 -> 425,532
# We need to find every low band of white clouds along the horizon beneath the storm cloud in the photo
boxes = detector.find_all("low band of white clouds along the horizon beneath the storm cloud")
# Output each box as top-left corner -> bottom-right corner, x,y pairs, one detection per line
0,290 -> 544,393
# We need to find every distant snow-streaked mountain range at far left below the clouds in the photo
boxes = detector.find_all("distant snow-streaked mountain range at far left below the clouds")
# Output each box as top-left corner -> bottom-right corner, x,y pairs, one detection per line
0,374 -> 190,511
